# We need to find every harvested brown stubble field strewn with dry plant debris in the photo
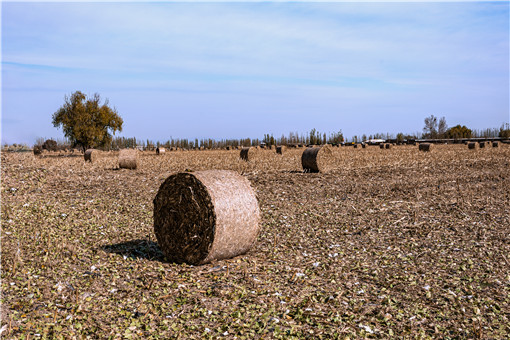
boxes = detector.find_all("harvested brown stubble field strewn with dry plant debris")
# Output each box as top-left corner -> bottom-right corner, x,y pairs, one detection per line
1,145 -> 510,339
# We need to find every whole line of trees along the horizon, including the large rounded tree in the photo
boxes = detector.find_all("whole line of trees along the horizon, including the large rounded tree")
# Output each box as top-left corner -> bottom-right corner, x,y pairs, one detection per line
44,91 -> 510,150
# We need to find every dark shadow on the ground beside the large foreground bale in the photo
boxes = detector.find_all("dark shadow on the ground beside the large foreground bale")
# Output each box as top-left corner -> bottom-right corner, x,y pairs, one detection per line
101,239 -> 165,262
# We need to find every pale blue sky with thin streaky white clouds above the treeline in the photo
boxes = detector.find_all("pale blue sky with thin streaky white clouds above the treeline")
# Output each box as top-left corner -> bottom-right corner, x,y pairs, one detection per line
1,1 -> 510,145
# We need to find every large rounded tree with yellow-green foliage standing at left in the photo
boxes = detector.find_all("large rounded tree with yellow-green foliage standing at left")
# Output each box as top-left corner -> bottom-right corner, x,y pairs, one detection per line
52,91 -> 123,151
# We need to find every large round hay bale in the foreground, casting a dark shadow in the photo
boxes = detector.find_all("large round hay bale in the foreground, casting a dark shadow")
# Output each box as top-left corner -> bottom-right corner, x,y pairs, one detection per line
154,170 -> 260,265
